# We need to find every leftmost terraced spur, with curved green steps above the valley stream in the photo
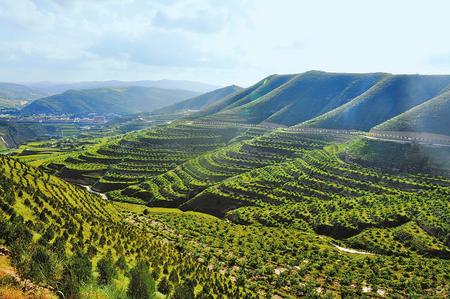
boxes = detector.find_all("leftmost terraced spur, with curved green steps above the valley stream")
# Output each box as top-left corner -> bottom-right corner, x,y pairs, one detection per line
48,124 -> 243,191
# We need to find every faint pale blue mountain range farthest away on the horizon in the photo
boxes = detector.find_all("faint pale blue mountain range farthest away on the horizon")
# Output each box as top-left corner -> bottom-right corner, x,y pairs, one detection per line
24,79 -> 219,94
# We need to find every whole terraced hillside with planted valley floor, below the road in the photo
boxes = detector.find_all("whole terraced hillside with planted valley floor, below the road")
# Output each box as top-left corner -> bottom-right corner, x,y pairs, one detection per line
8,121 -> 450,298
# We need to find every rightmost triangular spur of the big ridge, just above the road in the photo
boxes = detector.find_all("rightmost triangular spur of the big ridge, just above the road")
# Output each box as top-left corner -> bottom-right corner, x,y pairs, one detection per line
374,91 -> 450,135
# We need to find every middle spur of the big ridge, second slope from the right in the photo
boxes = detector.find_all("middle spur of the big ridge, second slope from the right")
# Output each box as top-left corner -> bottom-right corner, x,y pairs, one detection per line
301,75 -> 450,130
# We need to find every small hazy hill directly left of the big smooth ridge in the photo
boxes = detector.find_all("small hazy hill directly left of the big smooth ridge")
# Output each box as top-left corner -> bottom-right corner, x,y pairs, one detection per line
154,85 -> 243,114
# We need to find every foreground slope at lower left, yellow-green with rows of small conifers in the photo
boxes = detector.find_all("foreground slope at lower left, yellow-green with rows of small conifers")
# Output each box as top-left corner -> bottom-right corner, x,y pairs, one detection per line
0,156 -> 243,298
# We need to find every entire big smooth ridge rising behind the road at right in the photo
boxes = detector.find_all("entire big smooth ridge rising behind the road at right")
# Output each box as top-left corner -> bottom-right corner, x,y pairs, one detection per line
147,71 -> 450,132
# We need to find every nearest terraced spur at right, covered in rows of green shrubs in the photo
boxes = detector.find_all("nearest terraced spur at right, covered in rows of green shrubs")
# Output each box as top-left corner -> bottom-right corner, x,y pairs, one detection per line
197,150 -> 450,244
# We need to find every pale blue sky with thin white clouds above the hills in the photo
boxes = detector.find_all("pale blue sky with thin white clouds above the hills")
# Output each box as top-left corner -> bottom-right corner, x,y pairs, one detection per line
0,0 -> 450,86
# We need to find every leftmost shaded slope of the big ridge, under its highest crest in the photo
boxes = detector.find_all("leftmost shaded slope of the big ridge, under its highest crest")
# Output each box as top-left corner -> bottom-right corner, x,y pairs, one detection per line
217,71 -> 387,126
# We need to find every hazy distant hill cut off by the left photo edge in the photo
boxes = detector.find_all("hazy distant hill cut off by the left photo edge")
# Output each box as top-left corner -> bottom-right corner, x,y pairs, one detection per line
0,82 -> 48,108
